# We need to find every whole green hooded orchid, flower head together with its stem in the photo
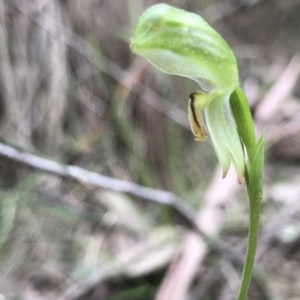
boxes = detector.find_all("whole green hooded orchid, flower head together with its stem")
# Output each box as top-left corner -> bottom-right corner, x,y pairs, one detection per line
131,4 -> 264,300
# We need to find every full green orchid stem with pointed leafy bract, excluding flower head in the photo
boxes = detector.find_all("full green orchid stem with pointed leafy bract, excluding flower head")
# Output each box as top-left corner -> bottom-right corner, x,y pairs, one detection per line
230,87 -> 264,300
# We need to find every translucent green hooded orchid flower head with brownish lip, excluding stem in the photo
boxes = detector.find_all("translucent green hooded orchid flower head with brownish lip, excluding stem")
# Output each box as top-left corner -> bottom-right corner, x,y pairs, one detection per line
131,4 -> 245,183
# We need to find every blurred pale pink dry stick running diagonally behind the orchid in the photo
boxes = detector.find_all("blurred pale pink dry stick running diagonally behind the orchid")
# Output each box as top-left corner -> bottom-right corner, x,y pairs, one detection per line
155,55 -> 300,300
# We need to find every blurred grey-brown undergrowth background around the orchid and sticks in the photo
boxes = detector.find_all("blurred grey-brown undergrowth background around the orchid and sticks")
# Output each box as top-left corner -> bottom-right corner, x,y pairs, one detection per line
0,0 -> 300,300
